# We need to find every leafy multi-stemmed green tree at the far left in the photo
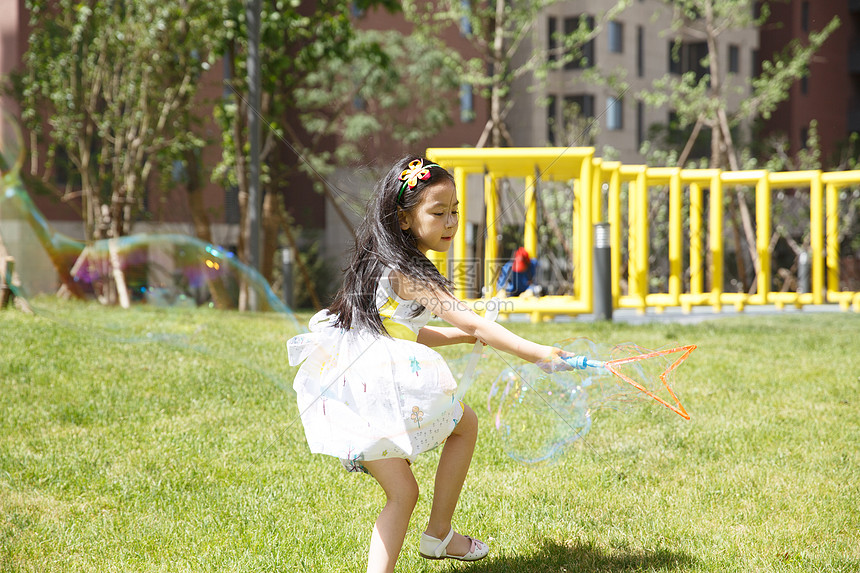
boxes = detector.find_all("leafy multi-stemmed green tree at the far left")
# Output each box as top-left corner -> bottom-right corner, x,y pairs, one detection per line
16,0 -> 222,240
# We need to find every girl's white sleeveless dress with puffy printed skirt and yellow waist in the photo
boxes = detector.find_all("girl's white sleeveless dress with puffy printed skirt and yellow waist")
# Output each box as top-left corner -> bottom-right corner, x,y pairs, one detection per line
287,269 -> 463,471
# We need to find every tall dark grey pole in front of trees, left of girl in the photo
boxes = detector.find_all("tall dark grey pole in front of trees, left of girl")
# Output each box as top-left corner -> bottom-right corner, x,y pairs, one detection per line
245,0 -> 262,310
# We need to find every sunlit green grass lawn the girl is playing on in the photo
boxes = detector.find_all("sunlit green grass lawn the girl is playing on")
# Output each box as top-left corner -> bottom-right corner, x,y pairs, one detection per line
0,301 -> 860,573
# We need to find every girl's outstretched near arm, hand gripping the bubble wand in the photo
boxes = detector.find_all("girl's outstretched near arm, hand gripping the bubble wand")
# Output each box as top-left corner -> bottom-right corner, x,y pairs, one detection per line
391,272 -> 570,371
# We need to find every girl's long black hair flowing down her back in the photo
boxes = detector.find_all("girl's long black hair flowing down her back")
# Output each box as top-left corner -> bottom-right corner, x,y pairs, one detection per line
329,156 -> 454,335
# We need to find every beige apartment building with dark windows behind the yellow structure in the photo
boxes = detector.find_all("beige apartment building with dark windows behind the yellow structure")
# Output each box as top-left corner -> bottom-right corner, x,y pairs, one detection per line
508,0 -> 758,163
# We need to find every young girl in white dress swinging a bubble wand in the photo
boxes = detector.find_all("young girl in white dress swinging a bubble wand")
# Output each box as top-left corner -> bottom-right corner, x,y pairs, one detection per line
288,157 -> 570,573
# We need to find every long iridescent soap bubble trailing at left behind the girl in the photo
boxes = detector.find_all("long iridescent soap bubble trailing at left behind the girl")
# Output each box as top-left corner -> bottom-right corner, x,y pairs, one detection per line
0,181 -> 292,314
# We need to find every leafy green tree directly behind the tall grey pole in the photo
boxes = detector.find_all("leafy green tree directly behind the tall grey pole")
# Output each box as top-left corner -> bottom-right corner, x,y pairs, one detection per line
215,0 -> 457,292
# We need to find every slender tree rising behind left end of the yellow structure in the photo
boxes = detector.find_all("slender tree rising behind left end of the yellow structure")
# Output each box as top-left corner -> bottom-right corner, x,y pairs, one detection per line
404,0 -> 629,147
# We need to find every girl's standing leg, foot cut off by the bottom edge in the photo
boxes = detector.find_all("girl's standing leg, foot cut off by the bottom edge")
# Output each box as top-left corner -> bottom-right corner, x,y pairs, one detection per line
362,459 -> 418,573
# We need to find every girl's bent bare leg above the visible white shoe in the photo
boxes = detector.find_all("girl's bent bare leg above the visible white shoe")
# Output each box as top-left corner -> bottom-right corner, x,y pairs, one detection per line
425,406 -> 478,555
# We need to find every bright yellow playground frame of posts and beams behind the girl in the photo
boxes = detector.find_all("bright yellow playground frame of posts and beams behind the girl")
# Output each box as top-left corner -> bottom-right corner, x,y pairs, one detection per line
427,147 -> 860,322
